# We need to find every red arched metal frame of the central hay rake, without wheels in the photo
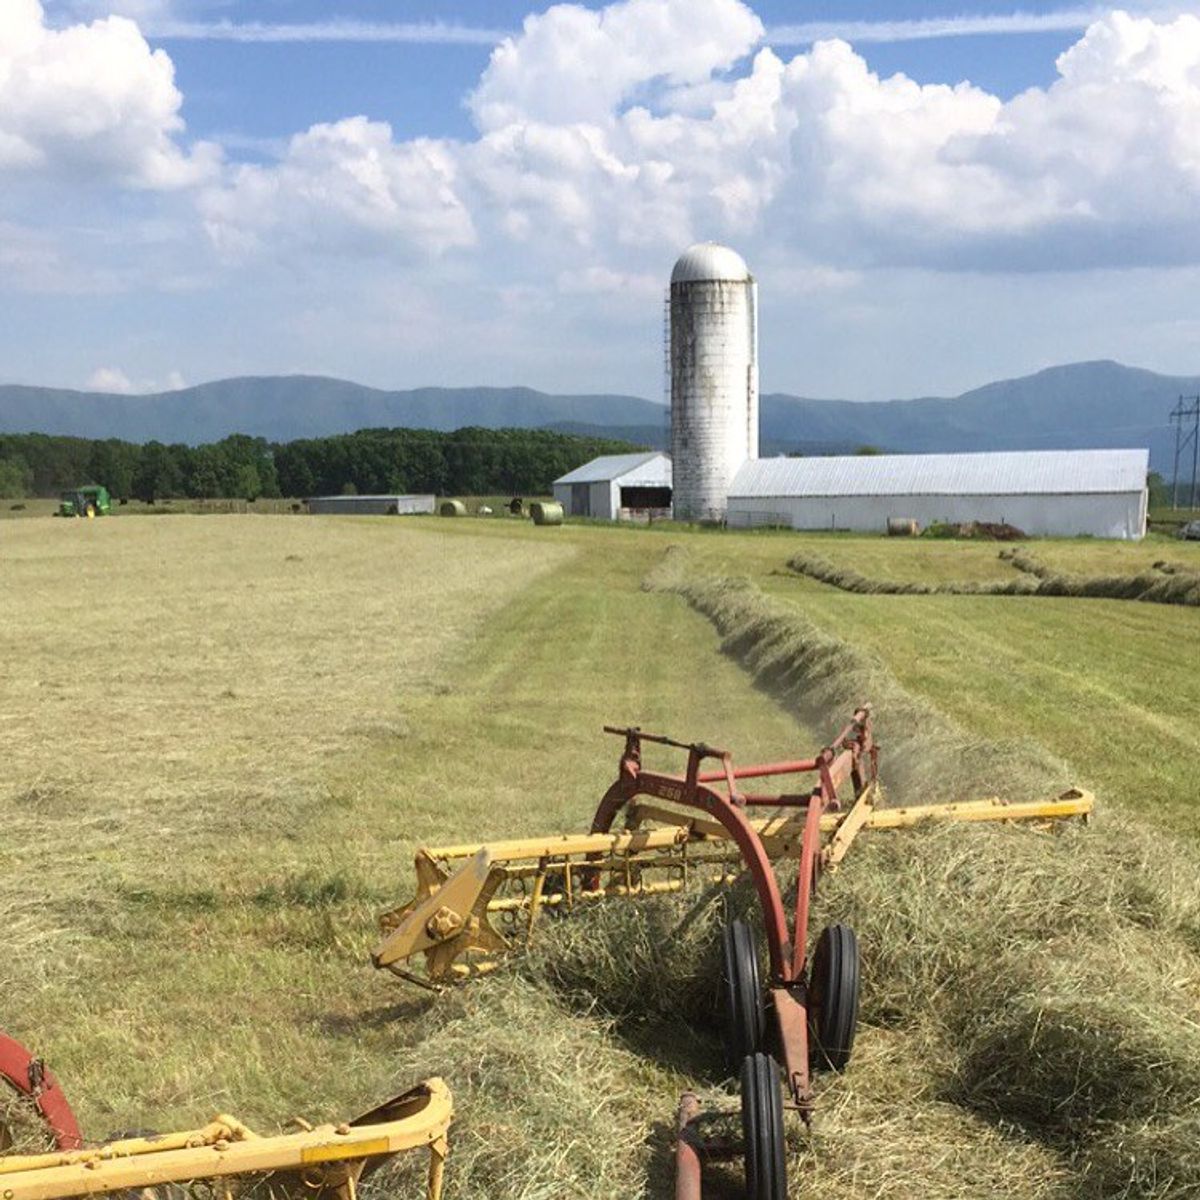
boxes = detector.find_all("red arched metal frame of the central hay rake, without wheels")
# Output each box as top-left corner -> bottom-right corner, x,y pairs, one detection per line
592,706 -> 878,1118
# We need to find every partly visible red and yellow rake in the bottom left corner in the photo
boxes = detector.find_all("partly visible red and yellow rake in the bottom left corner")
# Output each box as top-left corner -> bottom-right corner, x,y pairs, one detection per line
0,1033 -> 452,1200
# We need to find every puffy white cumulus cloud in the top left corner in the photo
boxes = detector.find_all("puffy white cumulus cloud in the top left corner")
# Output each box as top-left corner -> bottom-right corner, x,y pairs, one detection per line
0,0 -> 218,188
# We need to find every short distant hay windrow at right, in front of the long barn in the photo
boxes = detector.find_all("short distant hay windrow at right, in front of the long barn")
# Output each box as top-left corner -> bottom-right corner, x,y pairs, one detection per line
787,550 -> 1200,606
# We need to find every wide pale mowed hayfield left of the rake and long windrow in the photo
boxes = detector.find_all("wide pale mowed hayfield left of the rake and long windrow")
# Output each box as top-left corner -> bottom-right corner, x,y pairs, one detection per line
0,517 -> 812,1135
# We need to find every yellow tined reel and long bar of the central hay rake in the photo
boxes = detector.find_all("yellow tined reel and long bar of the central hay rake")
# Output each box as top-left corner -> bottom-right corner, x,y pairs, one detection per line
372,784 -> 1096,986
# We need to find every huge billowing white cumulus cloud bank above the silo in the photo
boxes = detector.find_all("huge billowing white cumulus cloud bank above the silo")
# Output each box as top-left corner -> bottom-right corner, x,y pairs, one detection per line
194,0 -> 1200,278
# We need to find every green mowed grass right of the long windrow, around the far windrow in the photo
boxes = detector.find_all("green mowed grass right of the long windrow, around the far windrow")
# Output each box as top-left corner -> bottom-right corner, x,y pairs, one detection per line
757,539 -> 1200,838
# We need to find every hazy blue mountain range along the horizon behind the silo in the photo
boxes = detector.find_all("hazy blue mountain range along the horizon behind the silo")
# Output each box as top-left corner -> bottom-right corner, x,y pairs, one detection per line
0,361 -> 1200,473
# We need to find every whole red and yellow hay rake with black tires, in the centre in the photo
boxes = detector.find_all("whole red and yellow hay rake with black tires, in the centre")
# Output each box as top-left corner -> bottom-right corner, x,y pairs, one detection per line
373,707 -> 1093,1200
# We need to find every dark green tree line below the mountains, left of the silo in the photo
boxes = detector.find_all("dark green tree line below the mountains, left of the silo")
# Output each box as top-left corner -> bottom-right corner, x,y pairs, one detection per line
0,427 -> 637,503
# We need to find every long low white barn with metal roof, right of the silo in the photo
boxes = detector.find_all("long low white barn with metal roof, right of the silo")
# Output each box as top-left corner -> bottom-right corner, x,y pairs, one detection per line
727,450 -> 1150,539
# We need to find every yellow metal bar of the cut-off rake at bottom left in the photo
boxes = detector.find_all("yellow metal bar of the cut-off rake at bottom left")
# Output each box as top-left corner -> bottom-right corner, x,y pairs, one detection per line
0,1079 -> 454,1200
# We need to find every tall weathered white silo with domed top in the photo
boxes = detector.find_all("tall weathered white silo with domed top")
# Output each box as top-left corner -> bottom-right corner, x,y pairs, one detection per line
670,241 -> 758,521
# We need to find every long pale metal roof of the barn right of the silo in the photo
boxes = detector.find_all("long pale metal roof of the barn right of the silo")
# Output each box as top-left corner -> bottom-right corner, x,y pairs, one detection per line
730,450 -> 1150,498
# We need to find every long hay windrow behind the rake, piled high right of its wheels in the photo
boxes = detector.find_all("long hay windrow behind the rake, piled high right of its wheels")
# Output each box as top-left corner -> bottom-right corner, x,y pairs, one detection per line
638,553 -> 1200,1198
